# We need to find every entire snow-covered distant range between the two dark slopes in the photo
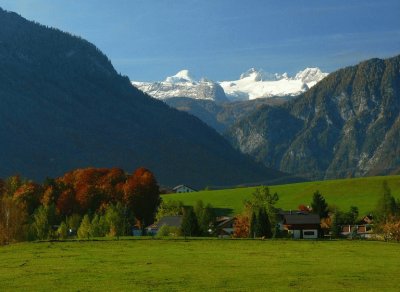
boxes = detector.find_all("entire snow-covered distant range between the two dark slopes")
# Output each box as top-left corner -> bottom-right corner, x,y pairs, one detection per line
132,68 -> 328,102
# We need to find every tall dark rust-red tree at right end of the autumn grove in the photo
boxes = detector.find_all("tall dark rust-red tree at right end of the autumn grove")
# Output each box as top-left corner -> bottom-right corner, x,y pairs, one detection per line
124,167 -> 160,228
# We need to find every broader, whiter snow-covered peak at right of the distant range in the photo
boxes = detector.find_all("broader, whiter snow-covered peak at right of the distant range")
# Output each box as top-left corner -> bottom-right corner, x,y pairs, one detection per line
219,68 -> 328,100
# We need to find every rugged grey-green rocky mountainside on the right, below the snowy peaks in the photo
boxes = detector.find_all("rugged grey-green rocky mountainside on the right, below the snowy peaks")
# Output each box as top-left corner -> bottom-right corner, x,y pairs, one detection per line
227,56 -> 400,178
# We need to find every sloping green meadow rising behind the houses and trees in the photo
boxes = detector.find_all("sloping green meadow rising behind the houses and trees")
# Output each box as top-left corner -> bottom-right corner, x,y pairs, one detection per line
163,176 -> 400,215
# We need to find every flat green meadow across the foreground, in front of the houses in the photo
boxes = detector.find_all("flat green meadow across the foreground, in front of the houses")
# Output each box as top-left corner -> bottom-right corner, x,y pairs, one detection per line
0,239 -> 400,291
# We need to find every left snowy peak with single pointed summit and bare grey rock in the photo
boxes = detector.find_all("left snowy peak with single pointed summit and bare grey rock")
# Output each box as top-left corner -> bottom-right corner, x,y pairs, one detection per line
132,70 -> 228,102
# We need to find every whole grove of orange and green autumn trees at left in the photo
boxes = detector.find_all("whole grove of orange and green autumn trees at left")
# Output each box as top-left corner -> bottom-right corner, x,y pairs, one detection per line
0,168 -> 160,244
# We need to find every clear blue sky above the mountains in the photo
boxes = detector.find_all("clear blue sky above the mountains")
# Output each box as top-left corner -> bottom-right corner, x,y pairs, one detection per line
0,0 -> 400,81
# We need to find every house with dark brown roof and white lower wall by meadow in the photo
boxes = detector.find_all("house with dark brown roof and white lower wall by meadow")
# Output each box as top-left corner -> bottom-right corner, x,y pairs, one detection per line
281,211 -> 321,239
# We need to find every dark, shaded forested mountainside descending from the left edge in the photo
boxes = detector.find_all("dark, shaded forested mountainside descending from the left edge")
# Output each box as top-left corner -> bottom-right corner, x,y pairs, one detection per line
0,10 -> 281,187
